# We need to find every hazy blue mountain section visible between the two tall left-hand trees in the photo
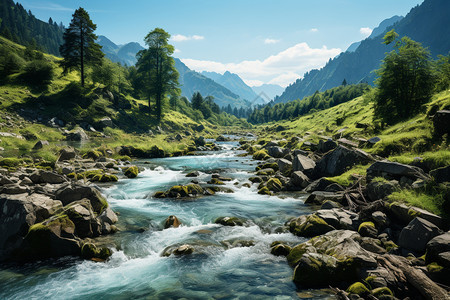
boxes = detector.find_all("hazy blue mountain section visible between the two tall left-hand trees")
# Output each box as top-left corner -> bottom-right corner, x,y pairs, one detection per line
97,35 -> 144,66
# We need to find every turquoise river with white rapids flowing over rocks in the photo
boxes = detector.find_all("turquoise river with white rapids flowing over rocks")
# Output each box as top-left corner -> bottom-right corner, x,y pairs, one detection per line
0,142 -> 330,299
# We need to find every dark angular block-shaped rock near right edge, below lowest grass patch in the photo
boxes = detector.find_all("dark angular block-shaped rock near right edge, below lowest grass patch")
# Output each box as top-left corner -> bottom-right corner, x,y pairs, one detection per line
398,217 -> 440,253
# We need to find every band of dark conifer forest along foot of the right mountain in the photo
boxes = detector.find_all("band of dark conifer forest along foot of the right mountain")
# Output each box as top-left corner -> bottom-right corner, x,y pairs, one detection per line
248,84 -> 370,124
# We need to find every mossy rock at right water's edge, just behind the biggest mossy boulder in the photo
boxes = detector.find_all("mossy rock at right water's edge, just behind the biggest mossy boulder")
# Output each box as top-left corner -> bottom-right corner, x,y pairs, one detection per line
288,214 -> 334,237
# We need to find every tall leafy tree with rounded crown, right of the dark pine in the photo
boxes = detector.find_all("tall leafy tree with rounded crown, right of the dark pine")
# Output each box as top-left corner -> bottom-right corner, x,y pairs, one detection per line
135,28 -> 179,121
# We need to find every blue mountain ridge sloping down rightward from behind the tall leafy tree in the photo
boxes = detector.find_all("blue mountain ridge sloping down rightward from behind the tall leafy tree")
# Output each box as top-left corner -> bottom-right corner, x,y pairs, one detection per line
175,58 -> 249,108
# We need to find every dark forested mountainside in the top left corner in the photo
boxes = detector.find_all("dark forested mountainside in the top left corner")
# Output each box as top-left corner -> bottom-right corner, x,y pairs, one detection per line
0,0 -> 64,56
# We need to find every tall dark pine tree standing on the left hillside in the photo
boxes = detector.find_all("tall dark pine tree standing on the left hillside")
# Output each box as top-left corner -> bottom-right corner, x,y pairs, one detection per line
59,7 -> 104,86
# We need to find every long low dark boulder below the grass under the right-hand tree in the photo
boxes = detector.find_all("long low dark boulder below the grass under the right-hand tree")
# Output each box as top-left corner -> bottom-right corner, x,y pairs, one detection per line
367,160 -> 428,180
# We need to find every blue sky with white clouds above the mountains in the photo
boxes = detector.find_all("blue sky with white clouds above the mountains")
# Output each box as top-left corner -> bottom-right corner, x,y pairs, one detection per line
19,0 -> 423,86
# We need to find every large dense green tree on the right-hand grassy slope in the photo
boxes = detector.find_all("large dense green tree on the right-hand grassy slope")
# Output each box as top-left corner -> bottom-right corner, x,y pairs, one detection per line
375,29 -> 434,124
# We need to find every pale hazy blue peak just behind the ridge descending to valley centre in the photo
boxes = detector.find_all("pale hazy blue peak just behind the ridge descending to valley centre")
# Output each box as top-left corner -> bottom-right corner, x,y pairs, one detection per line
202,71 -> 262,104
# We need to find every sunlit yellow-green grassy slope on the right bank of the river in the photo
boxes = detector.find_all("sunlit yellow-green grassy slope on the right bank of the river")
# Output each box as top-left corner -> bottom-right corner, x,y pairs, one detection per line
259,90 -> 450,214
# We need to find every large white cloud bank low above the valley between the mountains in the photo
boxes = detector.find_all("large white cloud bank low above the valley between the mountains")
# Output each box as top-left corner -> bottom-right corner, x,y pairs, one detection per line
182,43 -> 341,86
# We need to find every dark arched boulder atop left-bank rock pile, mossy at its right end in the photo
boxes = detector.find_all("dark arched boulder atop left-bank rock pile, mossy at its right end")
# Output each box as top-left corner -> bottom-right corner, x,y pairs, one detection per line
55,183 -> 108,214
